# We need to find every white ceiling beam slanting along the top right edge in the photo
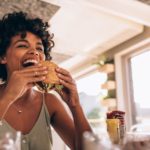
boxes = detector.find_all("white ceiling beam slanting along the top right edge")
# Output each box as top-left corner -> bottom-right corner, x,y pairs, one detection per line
44,0 -> 150,26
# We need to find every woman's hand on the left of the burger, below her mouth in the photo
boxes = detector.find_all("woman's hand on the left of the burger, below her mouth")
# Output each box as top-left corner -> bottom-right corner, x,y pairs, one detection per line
3,65 -> 47,101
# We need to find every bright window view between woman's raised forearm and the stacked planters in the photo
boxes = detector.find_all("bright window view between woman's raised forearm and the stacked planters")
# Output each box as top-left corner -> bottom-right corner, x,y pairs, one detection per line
76,72 -> 107,129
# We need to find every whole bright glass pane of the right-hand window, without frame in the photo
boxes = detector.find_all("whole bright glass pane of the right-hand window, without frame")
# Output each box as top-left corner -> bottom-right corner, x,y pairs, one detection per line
131,51 -> 150,123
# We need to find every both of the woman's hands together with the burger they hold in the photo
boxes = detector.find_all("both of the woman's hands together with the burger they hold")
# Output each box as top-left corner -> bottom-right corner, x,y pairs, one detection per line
1,61 -> 79,107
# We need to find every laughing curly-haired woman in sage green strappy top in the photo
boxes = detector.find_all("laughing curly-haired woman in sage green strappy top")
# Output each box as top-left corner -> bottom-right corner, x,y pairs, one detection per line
0,12 -> 91,150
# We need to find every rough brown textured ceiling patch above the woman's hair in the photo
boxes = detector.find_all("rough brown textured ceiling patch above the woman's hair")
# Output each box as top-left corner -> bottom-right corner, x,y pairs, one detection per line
0,0 -> 59,21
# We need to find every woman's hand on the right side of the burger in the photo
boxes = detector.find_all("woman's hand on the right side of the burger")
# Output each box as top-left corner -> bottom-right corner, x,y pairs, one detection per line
56,67 -> 79,107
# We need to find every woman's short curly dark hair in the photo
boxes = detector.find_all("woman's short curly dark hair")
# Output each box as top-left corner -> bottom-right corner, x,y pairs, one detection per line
0,11 -> 54,81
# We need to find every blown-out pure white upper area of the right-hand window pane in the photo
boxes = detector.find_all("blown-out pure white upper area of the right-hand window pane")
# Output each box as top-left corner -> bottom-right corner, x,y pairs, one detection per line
131,51 -> 150,108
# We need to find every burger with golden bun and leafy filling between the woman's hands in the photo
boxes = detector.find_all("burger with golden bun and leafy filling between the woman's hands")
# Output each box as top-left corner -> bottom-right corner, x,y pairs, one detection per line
35,60 -> 63,93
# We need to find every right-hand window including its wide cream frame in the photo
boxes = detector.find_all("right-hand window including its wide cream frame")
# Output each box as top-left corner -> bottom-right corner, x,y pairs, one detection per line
115,39 -> 150,130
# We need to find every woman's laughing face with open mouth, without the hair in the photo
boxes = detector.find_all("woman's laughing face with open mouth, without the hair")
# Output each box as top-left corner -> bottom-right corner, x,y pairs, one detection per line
5,32 -> 45,77
